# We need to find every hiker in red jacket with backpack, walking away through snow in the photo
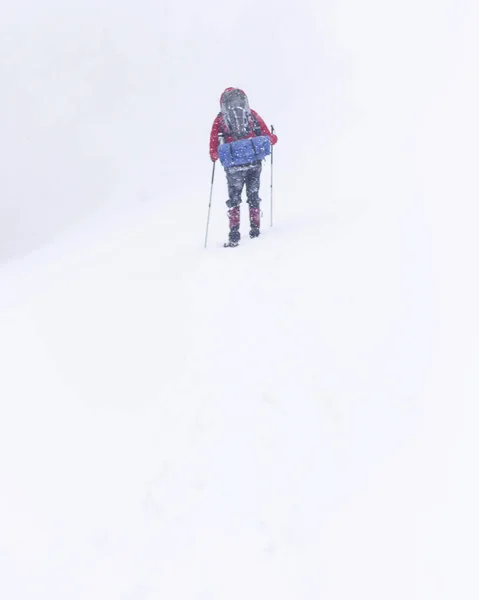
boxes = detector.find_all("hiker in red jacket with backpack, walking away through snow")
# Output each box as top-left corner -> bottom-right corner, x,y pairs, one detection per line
210,87 -> 278,247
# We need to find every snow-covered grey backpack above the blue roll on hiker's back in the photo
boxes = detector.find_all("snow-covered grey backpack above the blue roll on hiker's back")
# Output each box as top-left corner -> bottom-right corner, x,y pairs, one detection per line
219,89 -> 261,140
